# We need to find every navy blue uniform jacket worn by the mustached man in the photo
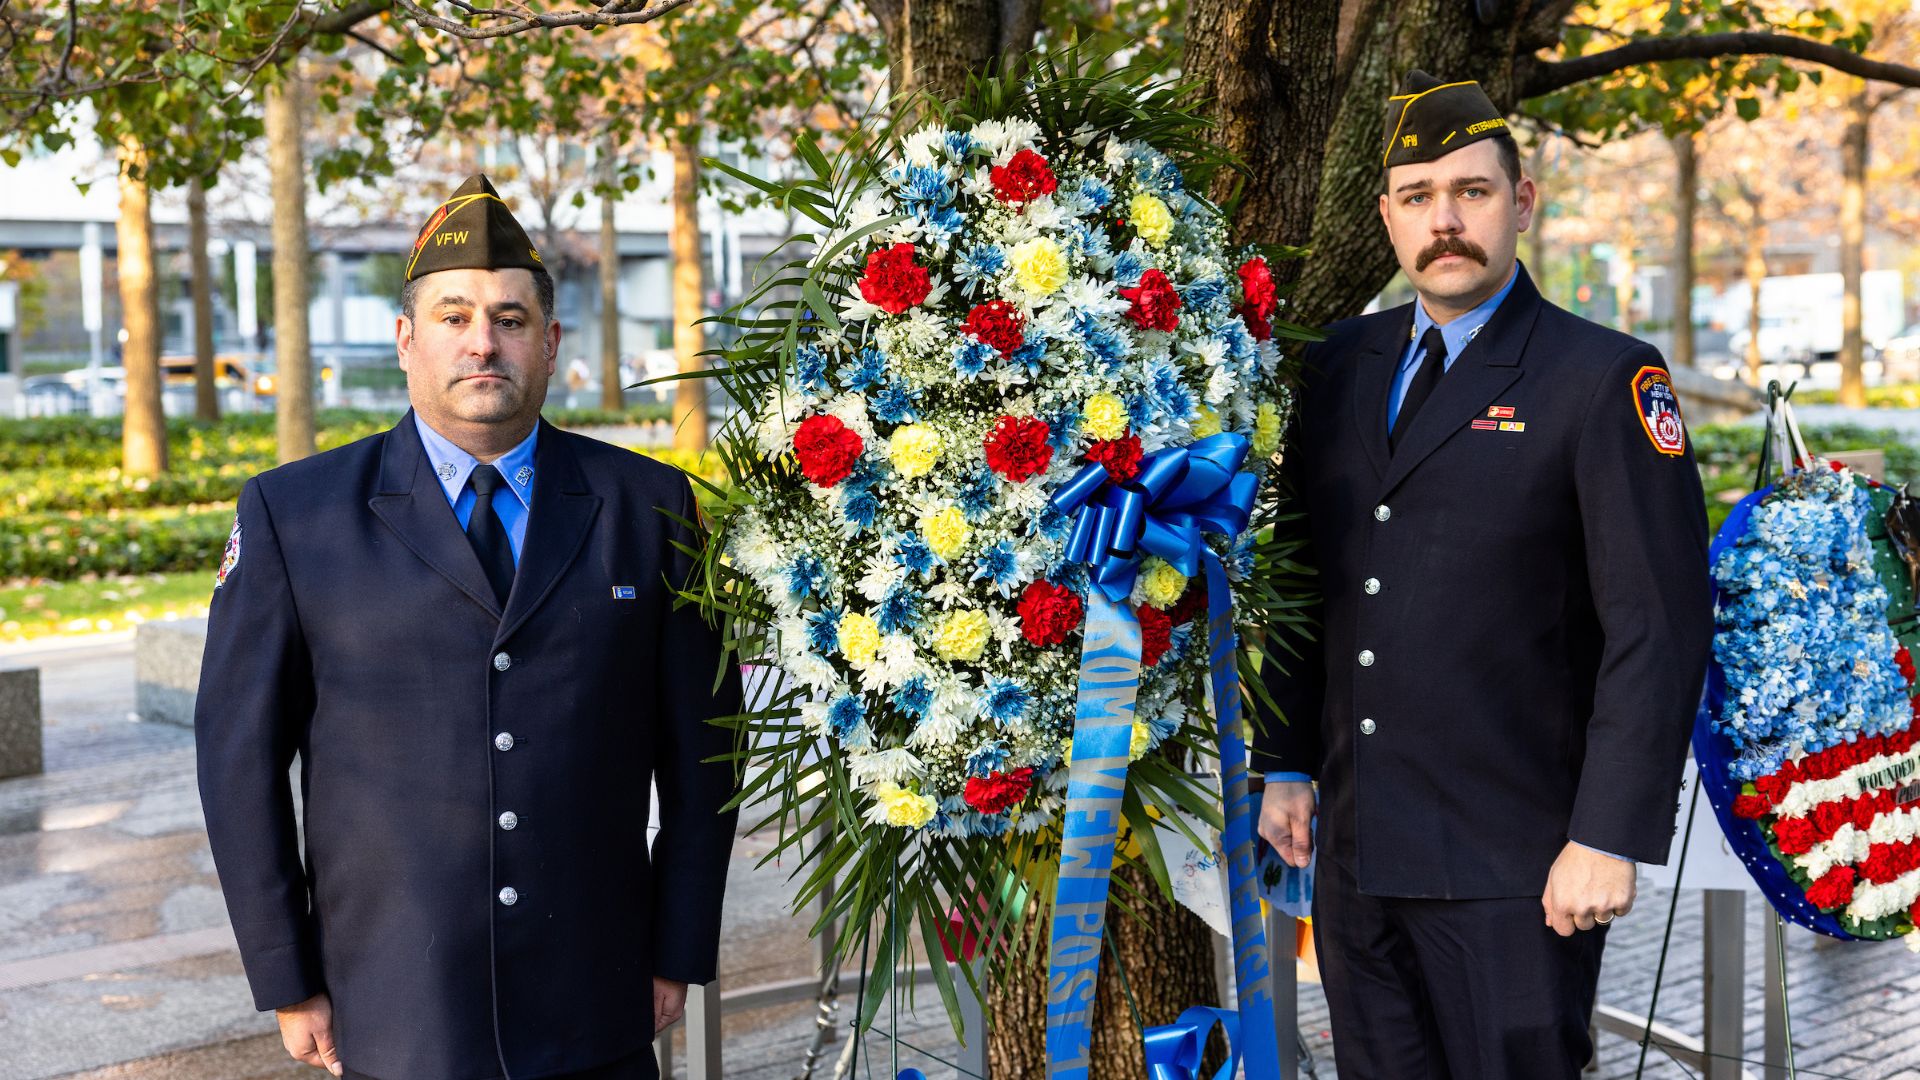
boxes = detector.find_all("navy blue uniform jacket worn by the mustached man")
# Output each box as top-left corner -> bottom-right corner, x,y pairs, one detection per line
1254,269 -> 1713,899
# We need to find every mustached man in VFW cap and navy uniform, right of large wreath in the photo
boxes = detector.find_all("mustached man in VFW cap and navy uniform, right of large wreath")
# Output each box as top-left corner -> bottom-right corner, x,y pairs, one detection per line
1254,71 -> 1713,1080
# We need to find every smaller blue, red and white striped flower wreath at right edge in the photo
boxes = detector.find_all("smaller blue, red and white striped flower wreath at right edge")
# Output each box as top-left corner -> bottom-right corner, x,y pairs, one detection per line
1693,402 -> 1920,951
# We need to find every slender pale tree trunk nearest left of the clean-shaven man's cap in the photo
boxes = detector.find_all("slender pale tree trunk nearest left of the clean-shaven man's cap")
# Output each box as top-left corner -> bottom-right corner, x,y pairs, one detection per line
267,65 -> 313,463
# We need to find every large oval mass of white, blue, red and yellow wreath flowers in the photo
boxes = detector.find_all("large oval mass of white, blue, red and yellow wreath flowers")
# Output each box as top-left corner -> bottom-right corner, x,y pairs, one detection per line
730,119 -> 1286,836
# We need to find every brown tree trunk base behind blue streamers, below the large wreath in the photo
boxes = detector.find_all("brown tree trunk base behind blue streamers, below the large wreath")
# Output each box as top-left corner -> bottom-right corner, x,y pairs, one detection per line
987,853 -> 1221,1080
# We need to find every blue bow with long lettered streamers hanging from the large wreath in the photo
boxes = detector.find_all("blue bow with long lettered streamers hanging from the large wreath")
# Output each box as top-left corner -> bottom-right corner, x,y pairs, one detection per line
1046,432 -> 1279,1080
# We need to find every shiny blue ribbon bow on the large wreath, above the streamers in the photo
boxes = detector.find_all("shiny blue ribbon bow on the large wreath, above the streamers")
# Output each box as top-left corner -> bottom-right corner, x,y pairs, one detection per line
1048,432 -> 1258,603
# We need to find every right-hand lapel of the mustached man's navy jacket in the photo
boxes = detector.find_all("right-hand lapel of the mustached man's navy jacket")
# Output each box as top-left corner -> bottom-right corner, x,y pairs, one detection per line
1380,263 -> 1540,498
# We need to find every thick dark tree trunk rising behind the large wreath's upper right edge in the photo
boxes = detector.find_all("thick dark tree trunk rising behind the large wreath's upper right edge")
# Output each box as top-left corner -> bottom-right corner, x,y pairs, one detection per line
1185,0 -> 1344,253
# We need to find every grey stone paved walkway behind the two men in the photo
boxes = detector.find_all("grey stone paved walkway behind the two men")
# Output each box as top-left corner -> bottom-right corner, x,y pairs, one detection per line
0,636 -> 1920,1080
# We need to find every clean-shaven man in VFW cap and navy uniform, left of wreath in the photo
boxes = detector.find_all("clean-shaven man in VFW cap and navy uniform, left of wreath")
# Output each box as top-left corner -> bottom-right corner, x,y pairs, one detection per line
194,177 -> 739,1080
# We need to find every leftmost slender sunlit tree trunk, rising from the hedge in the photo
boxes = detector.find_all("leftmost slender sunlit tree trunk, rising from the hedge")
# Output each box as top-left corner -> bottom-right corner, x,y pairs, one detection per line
115,138 -> 167,477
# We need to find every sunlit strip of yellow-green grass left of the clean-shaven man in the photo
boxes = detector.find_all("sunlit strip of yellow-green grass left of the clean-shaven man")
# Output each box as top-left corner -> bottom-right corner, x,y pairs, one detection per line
0,571 -> 213,642
